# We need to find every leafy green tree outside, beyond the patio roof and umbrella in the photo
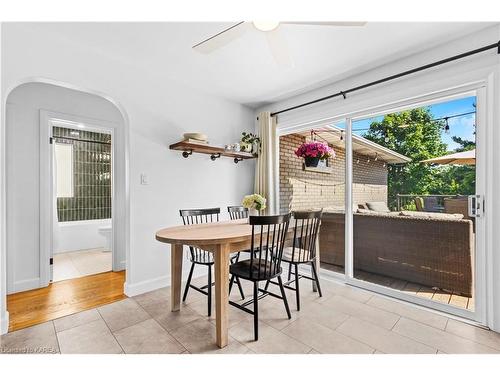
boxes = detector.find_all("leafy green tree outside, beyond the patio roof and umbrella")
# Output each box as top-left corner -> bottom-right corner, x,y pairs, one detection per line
364,107 -> 446,207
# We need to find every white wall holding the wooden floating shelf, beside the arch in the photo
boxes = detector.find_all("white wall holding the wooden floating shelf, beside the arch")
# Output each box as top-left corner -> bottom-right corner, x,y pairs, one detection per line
2,24 -> 254,306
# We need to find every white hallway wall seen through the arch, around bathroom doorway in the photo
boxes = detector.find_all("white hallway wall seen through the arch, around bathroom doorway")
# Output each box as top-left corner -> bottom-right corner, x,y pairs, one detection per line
5,83 -> 125,293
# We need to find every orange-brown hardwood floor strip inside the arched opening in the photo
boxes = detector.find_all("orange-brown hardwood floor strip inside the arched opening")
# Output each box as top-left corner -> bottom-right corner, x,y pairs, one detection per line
7,271 -> 126,332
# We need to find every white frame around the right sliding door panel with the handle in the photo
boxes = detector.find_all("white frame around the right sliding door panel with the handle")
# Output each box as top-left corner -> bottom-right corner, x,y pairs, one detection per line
345,82 -> 491,325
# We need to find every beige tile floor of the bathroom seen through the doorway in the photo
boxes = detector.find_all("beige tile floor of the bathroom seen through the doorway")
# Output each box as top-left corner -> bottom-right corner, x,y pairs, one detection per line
53,248 -> 112,281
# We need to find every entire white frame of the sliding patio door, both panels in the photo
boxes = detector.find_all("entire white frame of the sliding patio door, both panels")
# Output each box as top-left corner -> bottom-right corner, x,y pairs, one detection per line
277,80 -> 492,325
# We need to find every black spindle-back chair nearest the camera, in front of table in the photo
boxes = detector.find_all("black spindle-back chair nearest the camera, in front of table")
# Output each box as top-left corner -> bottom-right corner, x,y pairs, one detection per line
229,214 -> 292,341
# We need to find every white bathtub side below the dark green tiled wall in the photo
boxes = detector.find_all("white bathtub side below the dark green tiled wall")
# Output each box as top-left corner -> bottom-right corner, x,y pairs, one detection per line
54,219 -> 111,254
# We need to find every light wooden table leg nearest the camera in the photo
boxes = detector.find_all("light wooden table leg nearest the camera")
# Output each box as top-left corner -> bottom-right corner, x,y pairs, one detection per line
214,245 -> 229,348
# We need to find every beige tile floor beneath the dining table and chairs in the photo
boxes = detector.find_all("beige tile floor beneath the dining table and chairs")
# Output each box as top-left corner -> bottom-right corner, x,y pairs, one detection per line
0,279 -> 500,354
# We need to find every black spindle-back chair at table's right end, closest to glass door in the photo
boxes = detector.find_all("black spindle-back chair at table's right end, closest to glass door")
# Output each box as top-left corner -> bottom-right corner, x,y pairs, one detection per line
265,210 -> 323,310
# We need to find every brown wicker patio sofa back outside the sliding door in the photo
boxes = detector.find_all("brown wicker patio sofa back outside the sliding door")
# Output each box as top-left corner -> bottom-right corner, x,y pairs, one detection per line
320,212 -> 474,297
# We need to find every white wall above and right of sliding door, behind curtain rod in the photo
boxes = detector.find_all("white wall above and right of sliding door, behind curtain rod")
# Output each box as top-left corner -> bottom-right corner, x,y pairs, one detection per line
256,26 -> 500,331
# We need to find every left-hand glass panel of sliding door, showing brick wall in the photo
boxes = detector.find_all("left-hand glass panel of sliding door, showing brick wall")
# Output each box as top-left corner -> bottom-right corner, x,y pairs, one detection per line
279,121 -> 346,275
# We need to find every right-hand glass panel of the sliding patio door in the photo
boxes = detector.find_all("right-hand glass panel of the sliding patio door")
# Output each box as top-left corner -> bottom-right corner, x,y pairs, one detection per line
346,90 -> 484,321
